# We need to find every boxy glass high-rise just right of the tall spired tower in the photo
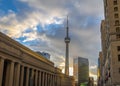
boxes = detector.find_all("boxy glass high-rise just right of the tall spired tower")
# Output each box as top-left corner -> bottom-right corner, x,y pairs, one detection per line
73,57 -> 89,86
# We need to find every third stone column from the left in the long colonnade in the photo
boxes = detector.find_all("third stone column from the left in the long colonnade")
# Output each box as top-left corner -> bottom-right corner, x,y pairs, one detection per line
14,63 -> 20,86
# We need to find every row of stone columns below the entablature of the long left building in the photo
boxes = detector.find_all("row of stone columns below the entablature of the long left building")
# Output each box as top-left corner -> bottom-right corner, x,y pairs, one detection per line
0,57 -> 61,86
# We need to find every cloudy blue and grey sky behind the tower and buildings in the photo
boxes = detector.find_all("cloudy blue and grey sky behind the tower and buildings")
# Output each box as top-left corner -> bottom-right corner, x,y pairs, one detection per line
0,0 -> 104,79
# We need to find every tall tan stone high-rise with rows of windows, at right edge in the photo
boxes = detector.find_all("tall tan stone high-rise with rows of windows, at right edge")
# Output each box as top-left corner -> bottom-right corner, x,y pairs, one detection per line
100,0 -> 120,86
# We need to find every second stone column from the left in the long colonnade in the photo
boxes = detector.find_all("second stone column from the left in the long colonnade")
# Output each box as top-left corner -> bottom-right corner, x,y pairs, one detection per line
8,62 -> 14,86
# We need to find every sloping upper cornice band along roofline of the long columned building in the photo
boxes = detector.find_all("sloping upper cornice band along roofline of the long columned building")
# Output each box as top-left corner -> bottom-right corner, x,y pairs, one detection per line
0,32 -> 54,66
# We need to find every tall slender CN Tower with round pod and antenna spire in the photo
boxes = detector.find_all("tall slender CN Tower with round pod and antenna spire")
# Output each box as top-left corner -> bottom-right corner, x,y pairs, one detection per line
65,17 -> 70,75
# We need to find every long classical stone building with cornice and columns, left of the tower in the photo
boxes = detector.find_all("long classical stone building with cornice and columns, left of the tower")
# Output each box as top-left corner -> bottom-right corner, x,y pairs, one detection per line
0,33 -> 74,86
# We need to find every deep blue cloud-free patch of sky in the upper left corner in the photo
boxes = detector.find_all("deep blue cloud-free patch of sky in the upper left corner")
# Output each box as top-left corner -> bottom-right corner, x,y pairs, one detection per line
0,0 -> 30,15
